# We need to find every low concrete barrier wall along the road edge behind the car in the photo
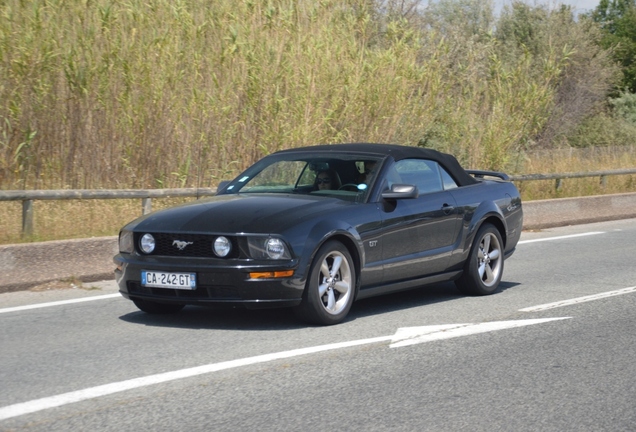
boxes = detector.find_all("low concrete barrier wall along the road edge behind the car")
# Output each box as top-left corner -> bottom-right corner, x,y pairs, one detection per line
0,193 -> 636,293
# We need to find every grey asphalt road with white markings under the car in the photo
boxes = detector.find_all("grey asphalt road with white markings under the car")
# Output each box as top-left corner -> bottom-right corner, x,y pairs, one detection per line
0,219 -> 636,431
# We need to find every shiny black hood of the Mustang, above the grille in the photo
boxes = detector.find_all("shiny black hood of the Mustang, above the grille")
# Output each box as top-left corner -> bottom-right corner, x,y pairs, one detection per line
126,194 -> 355,233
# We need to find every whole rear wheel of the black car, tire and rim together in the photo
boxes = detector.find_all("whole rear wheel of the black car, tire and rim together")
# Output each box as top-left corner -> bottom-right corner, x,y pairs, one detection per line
455,224 -> 504,296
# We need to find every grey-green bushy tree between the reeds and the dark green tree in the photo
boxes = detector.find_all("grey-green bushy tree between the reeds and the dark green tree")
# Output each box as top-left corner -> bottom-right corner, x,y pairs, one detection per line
496,1 -> 617,148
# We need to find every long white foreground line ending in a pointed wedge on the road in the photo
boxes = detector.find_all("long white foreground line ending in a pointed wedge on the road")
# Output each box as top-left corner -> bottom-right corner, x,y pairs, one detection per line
0,317 -> 569,421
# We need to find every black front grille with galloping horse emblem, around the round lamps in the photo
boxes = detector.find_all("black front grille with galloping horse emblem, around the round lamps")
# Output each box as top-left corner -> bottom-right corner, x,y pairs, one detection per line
136,233 -> 240,258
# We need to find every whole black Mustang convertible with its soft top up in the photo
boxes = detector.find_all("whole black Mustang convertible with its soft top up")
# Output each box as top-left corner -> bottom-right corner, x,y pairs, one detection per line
114,144 -> 523,324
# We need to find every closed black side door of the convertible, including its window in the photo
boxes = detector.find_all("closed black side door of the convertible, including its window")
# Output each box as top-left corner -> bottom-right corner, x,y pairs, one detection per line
382,159 -> 460,283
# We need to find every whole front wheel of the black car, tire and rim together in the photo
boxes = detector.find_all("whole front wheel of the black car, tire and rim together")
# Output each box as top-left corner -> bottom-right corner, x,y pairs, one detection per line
294,241 -> 356,325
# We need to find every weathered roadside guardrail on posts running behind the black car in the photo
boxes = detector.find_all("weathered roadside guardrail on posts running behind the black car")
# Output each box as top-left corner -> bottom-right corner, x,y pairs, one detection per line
0,168 -> 636,237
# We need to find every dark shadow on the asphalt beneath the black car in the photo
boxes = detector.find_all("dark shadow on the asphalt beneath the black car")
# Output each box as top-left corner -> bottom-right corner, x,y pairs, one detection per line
120,282 -> 519,331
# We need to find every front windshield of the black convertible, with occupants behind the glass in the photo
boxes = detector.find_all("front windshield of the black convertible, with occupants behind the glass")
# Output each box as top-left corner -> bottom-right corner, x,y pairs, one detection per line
224,153 -> 381,202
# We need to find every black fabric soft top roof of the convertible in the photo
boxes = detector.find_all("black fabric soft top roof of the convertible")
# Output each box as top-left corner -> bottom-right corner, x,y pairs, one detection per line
277,143 -> 477,186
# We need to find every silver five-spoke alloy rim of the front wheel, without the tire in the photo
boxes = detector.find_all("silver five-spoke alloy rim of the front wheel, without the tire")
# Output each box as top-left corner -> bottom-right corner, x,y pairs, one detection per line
318,251 -> 353,315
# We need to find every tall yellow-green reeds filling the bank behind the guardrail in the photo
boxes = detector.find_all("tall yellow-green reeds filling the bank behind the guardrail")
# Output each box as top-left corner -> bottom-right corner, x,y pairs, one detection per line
0,0 -> 570,189
